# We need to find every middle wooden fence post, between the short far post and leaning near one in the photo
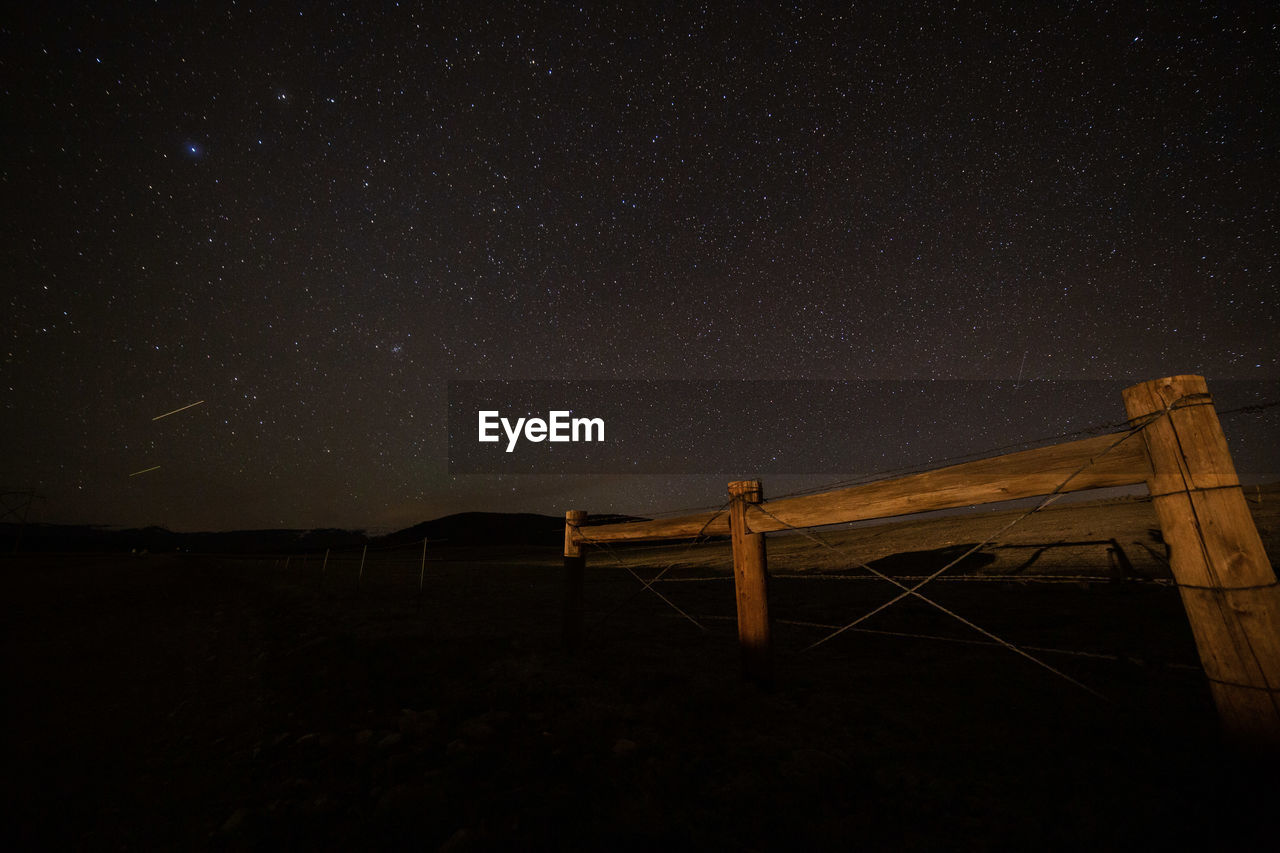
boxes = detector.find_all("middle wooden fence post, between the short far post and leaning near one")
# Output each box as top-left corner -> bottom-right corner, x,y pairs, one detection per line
728,480 -> 773,684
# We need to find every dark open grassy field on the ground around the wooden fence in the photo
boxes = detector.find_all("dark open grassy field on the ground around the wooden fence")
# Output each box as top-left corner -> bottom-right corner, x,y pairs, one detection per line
0,491 -> 1280,850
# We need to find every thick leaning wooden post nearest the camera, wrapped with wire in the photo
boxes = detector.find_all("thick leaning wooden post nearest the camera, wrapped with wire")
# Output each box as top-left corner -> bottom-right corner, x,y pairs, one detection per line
1124,375 -> 1280,749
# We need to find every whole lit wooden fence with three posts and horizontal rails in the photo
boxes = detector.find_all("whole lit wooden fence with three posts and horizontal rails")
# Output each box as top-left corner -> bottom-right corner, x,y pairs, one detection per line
564,375 -> 1280,748
